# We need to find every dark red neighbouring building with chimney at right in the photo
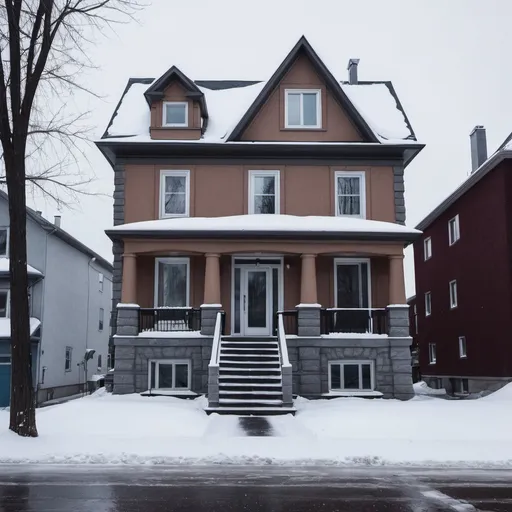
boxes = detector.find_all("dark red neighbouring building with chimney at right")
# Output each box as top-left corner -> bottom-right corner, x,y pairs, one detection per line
414,126 -> 512,395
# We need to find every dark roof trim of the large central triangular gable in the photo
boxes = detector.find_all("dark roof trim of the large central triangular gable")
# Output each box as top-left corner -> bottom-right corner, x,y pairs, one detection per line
227,36 -> 378,142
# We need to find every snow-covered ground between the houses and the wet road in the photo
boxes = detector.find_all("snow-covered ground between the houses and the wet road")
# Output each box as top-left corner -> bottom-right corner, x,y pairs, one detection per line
0,385 -> 512,466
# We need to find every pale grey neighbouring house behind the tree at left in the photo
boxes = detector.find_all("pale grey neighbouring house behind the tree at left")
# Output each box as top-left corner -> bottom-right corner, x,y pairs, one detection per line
0,192 -> 112,407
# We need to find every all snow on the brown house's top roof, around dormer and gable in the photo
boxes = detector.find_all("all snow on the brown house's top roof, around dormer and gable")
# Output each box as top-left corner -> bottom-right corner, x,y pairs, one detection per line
107,82 -> 412,143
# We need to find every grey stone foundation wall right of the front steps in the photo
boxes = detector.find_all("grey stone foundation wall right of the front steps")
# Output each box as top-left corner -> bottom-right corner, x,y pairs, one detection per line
287,338 -> 414,400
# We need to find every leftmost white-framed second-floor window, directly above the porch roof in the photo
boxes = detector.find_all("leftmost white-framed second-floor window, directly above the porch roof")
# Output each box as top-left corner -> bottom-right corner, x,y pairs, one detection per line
160,171 -> 190,217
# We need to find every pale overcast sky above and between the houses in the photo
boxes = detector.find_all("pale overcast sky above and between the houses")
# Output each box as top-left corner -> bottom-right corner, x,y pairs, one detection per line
29,0 -> 512,295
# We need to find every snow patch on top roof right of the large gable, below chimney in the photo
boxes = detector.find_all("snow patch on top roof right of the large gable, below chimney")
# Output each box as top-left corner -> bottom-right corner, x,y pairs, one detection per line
342,83 -> 412,140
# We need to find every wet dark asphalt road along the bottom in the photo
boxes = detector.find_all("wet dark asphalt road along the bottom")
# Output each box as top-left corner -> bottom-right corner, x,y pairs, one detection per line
0,466 -> 512,512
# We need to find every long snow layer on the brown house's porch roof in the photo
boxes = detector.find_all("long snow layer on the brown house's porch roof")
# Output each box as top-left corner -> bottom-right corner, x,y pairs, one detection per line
111,214 -> 420,234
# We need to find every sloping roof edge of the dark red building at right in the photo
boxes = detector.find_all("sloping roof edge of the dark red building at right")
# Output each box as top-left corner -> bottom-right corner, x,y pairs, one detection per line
416,133 -> 512,231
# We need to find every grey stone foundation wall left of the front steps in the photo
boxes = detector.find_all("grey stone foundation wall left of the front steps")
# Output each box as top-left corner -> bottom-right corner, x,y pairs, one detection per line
113,337 -> 213,395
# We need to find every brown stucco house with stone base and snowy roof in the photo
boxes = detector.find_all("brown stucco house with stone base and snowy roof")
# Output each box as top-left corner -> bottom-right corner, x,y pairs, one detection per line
97,37 -> 423,414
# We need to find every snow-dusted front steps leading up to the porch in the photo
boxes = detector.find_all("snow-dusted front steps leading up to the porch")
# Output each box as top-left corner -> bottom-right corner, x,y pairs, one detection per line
206,337 -> 295,416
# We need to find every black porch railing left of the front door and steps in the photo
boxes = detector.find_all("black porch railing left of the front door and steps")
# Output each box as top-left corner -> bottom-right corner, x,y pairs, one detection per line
139,308 -> 201,332
